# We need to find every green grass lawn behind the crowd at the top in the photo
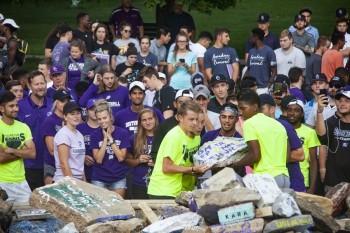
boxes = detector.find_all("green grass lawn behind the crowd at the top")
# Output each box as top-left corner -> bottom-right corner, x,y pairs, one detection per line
0,0 -> 350,69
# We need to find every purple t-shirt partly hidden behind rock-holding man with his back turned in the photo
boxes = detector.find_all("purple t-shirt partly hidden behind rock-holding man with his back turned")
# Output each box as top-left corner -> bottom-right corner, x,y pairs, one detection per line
276,119 -> 305,192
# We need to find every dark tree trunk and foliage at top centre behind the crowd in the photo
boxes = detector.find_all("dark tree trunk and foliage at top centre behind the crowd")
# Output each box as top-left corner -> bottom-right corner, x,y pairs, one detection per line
144,0 -> 237,27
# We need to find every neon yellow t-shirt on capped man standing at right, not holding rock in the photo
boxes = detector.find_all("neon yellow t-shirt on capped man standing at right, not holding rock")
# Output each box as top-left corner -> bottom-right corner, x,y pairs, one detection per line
295,125 -> 321,187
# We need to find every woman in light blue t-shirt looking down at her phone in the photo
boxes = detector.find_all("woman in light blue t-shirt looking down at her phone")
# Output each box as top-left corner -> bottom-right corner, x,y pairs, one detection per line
168,33 -> 197,90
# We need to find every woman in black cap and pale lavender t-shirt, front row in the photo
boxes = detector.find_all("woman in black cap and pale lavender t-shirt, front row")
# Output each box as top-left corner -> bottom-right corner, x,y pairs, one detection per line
53,102 -> 86,182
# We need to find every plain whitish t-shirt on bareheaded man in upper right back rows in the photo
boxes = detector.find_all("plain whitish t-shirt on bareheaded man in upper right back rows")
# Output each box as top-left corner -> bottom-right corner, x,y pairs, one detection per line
275,47 -> 306,76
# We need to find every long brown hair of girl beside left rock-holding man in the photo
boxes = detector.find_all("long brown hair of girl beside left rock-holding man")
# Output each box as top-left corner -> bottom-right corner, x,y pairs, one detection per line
134,108 -> 158,158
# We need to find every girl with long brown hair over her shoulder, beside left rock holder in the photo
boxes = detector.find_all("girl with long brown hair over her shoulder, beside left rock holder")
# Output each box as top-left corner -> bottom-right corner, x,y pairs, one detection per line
126,108 -> 158,199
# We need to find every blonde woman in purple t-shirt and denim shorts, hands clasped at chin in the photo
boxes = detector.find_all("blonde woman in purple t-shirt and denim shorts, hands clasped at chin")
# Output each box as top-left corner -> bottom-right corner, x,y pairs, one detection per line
90,99 -> 130,198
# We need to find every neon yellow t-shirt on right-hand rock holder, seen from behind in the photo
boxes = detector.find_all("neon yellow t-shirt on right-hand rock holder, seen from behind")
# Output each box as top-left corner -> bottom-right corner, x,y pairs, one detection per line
243,113 -> 289,177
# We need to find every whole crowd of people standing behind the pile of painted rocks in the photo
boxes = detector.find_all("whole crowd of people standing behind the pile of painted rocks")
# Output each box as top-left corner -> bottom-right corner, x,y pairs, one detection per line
0,0 -> 350,202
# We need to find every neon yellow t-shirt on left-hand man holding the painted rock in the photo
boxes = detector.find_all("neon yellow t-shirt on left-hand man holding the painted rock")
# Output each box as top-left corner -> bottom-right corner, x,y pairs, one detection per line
148,126 -> 200,197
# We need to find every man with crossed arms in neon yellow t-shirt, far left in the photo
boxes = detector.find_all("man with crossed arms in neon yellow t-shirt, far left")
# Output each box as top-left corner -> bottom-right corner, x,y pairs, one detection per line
0,91 -> 35,202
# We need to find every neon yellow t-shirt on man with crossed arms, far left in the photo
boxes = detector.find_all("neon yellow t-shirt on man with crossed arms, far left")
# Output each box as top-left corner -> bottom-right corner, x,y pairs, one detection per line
0,120 -> 33,183
